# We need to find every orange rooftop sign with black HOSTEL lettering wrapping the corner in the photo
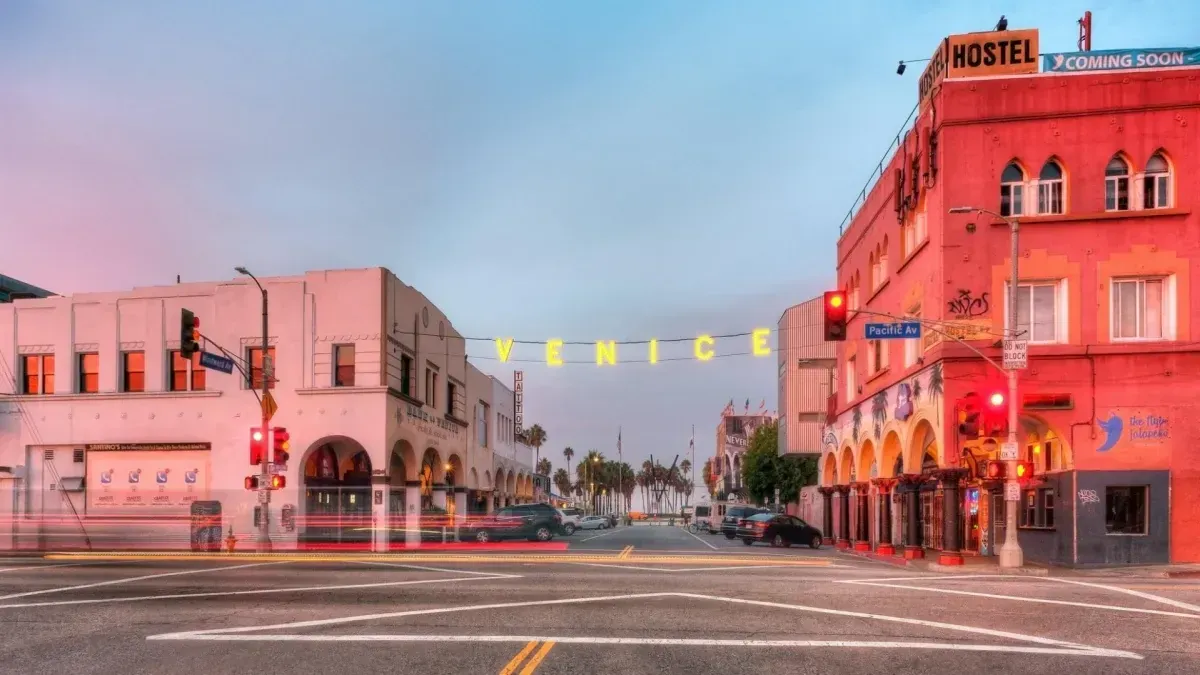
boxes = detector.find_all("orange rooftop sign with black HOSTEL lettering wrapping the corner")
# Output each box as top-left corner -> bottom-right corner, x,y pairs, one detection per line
917,28 -> 1039,110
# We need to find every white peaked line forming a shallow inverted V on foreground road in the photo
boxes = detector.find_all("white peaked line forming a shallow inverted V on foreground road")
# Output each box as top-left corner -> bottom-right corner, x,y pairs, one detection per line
146,592 -> 1141,659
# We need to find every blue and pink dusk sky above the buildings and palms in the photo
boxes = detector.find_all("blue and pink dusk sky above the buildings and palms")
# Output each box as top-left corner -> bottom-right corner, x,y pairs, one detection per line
0,0 -> 1200,504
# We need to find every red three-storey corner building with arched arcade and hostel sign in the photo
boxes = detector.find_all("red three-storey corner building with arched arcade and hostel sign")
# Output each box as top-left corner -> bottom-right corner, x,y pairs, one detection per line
821,31 -> 1200,566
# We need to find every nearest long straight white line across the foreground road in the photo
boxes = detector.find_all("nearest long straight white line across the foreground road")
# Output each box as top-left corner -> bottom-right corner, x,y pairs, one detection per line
146,633 -> 1142,661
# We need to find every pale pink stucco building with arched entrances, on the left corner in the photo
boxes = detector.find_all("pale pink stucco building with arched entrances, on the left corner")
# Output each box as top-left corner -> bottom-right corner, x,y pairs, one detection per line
0,268 -> 532,550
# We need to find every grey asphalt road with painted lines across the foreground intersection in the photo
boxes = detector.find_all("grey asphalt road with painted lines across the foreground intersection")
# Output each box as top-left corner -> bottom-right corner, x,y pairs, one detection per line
0,527 -> 1200,675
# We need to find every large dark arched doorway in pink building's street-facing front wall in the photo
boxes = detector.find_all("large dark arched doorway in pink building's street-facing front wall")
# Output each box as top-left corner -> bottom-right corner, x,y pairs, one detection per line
298,437 -> 371,546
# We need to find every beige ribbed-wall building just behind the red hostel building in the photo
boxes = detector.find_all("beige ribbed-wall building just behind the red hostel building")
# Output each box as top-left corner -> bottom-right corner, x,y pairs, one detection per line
776,298 -> 838,455
